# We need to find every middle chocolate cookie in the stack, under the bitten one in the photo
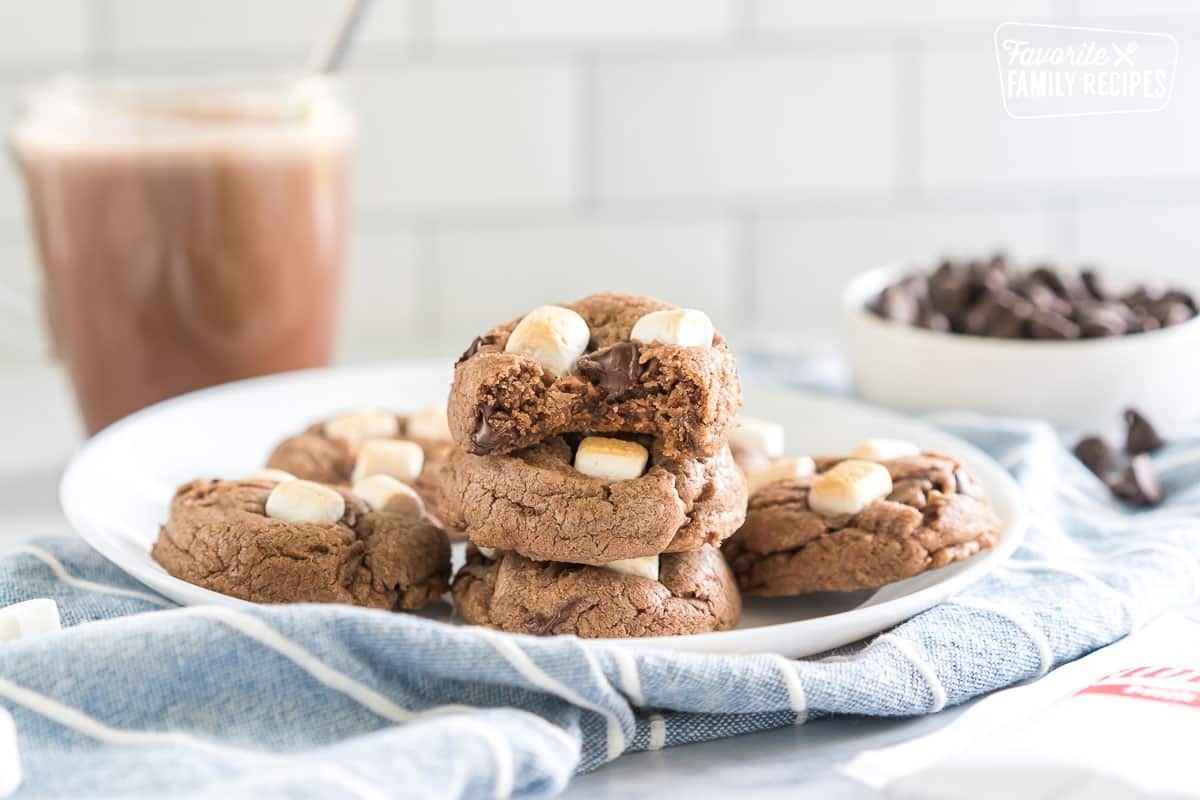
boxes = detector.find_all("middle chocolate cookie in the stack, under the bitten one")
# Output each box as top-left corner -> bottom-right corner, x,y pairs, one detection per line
443,437 -> 746,564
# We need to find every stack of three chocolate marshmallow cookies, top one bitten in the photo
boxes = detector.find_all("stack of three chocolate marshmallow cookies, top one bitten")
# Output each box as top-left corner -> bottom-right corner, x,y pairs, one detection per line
440,293 -> 746,637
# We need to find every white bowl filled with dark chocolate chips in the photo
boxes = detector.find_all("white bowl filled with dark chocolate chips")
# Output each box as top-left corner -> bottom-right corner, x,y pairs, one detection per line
844,255 -> 1200,429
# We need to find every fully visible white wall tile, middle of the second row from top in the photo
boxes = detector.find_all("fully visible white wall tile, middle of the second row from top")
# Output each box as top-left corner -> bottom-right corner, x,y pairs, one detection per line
594,52 -> 896,203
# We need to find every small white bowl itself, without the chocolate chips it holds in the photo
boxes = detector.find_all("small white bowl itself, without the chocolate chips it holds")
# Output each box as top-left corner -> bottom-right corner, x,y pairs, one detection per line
842,265 -> 1200,429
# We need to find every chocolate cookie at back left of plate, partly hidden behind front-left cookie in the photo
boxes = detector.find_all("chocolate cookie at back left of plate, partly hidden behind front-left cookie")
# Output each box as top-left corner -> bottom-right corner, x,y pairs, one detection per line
266,415 -> 454,525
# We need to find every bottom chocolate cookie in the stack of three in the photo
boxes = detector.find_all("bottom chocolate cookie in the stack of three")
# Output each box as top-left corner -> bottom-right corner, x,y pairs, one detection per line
452,547 -> 742,638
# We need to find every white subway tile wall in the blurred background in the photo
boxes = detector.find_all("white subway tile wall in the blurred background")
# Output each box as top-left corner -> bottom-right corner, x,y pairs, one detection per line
0,0 -> 1200,368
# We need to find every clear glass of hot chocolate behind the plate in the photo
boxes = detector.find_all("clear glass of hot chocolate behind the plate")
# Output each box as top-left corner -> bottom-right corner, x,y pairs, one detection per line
10,78 -> 354,433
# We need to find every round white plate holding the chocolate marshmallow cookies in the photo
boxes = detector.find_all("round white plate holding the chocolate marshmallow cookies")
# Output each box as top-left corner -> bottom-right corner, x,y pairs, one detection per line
60,362 -> 1025,656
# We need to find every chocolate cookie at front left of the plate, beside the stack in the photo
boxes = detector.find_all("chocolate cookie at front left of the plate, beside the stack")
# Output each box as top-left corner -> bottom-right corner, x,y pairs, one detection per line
151,479 -> 450,609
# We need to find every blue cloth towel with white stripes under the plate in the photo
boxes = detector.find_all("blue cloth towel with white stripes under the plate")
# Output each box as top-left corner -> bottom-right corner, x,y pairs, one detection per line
0,415 -> 1200,799
